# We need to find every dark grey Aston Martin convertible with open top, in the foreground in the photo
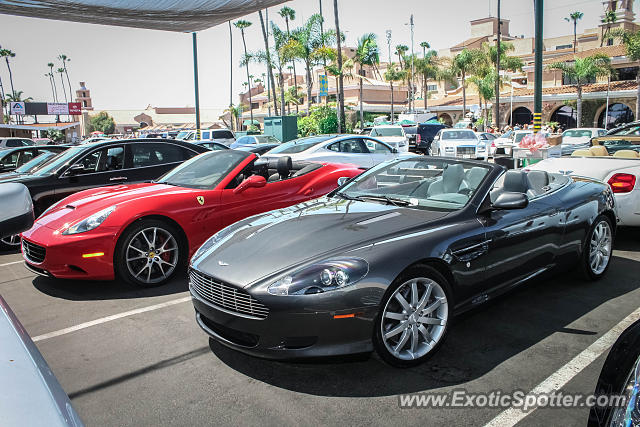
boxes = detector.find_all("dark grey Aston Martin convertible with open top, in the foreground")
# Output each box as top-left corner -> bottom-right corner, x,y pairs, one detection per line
189,157 -> 617,366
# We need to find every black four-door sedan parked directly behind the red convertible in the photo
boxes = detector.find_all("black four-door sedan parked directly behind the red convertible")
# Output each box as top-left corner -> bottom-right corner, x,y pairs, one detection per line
0,139 -> 208,251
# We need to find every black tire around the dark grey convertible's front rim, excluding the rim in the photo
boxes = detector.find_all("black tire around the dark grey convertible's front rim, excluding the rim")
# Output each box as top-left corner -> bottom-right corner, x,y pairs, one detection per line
373,265 -> 453,368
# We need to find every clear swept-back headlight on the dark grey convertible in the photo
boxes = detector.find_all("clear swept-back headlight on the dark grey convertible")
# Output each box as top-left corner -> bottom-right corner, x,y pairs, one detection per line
268,258 -> 369,295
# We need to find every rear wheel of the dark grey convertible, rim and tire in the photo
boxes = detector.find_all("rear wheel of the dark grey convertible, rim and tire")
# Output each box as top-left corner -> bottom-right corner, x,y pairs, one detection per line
583,216 -> 613,280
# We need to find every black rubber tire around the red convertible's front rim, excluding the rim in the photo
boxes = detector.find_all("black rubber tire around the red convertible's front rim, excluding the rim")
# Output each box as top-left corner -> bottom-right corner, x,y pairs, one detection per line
113,219 -> 187,287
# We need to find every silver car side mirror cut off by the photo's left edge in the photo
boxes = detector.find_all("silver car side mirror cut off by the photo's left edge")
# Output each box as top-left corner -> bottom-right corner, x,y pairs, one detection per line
0,183 -> 35,238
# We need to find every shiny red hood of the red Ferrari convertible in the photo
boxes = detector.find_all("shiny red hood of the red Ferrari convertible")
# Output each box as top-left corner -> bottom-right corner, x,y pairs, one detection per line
36,183 -> 193,229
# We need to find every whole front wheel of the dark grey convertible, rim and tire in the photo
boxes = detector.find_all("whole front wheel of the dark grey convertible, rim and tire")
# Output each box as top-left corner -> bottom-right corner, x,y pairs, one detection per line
373,266 -> 452,368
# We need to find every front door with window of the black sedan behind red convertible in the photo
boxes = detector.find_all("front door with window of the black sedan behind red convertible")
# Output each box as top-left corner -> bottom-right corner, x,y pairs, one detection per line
54,144 -> 126,200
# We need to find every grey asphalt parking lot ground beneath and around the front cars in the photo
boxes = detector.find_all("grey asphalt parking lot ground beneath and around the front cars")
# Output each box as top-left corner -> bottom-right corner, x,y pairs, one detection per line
0,229 -> 640,426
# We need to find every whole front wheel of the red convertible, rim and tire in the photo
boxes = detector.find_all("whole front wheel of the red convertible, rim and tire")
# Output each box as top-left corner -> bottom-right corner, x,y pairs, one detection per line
115,220 -> 186,287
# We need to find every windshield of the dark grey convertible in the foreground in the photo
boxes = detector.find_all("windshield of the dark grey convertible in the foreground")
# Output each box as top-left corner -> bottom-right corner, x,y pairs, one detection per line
337,158 -> 491,211
